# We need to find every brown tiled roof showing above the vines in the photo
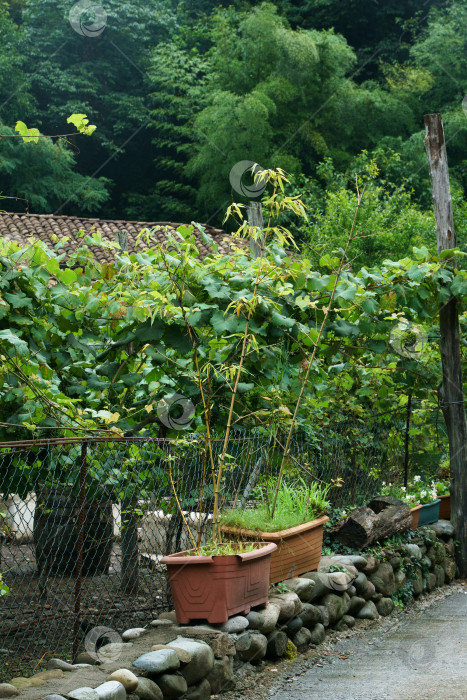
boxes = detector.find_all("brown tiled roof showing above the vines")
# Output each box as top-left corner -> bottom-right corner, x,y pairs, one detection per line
0,213 -> 232,262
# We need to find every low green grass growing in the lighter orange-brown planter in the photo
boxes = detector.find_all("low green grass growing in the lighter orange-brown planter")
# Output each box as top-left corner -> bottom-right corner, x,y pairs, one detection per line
221,479 -> 330,532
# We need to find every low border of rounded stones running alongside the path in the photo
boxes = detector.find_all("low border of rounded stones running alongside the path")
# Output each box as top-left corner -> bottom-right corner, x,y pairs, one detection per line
0,521 -> 456,700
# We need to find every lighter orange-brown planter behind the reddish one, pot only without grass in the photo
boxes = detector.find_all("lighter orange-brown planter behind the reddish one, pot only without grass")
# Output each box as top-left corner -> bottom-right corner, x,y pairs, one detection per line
221,515 -> 329,583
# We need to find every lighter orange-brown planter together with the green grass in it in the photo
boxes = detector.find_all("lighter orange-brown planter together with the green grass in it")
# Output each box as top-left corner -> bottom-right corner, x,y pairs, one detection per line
221,479 -> 330,583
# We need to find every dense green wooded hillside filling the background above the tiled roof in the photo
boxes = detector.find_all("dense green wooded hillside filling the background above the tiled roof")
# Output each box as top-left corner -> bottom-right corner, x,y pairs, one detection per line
0,0 -> 467,230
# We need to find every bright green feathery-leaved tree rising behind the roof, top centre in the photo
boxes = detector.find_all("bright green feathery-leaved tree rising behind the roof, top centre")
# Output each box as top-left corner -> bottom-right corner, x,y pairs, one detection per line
186,4 -> 412,216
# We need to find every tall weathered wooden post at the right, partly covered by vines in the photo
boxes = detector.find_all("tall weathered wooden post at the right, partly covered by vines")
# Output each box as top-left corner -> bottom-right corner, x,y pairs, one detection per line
424,114 -> 467,577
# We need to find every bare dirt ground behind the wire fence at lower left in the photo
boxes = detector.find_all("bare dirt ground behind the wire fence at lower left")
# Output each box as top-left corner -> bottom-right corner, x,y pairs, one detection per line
0,543 -> 167,682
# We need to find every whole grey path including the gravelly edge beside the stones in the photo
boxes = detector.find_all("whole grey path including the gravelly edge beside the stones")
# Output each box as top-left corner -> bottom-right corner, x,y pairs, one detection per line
224,581 -> 467,700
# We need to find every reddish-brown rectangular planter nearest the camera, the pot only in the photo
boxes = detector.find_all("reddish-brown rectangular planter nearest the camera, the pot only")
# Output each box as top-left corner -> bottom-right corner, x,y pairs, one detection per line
161,542 -> 277,625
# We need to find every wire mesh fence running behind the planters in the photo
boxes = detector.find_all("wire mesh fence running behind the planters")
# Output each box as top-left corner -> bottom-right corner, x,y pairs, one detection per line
0,426 -> 394,679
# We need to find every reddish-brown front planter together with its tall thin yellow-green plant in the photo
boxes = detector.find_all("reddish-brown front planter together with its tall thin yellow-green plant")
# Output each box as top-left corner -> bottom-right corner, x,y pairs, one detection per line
162,171 -> 304,623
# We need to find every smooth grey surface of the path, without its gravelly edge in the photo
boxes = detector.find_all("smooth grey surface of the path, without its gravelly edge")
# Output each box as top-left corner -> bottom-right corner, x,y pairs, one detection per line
269,592 -> 467,700
